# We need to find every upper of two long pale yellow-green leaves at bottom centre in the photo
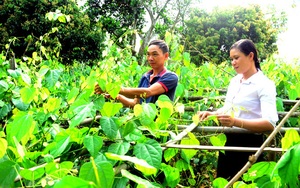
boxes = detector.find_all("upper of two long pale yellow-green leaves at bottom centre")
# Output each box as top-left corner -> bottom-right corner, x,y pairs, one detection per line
105,153 -> 157,176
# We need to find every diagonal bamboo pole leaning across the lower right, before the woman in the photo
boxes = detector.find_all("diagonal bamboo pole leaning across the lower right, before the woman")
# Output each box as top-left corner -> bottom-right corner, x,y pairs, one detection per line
225,100 -> 300,188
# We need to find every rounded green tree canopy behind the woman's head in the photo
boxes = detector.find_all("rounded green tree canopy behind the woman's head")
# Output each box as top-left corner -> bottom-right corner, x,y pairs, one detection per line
184,5 -> 286,64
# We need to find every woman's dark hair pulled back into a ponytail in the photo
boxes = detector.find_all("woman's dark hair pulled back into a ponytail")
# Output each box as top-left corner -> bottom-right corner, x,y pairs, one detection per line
230,39 -> 261,70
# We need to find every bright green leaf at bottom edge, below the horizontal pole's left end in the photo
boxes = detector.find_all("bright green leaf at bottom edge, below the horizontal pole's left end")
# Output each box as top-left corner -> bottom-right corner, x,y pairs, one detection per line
161,163 -> 180,187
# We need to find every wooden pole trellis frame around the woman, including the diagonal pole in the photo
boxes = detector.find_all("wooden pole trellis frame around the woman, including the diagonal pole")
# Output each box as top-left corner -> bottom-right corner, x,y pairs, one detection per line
80,97 -> 300,188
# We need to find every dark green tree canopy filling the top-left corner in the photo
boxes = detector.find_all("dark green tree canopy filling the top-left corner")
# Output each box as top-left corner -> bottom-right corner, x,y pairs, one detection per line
0,0 -> 104,62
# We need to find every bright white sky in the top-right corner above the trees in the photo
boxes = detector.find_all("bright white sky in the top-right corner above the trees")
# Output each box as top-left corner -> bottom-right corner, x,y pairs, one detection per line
199,0 -> 300,62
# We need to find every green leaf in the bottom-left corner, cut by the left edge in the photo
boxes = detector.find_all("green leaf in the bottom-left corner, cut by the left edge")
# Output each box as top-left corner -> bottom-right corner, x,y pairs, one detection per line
0,160 -> 20,187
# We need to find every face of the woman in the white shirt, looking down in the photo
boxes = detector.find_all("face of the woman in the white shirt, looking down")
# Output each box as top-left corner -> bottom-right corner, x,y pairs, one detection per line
230,48 -> 255,74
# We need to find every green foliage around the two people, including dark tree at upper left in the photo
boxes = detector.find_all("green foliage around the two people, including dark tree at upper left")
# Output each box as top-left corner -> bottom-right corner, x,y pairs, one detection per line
0,1 -> 300,188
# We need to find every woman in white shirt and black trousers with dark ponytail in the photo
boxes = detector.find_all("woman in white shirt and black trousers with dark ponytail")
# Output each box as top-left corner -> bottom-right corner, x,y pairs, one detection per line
198,39 -> 278,179
